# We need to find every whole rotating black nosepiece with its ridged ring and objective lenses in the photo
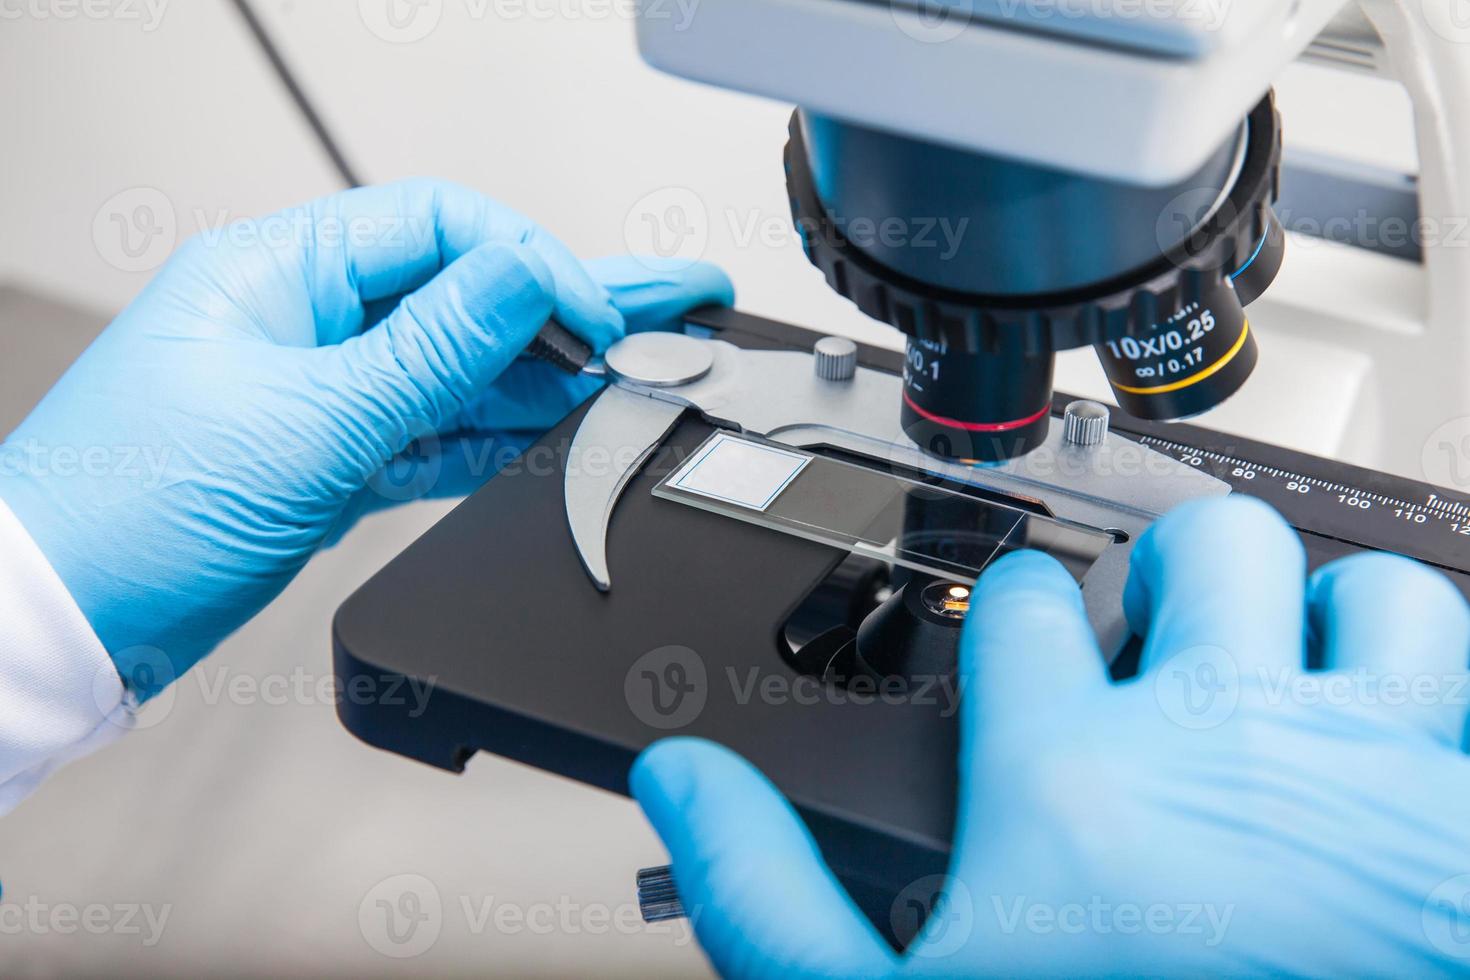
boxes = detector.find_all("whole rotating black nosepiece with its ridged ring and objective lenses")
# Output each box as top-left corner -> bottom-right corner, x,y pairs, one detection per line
785,96 -> 1283,461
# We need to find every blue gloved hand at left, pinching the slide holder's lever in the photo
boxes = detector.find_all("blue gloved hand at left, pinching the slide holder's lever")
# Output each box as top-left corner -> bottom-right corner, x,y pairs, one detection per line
0,181 -> 731,698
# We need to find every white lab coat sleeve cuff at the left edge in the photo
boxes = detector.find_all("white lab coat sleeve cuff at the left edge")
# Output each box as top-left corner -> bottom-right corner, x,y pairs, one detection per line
0,501 -> 137,815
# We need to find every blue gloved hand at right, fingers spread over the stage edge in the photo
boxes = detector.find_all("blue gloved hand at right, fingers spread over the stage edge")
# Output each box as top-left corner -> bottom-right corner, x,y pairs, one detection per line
632,498 -> 1470,977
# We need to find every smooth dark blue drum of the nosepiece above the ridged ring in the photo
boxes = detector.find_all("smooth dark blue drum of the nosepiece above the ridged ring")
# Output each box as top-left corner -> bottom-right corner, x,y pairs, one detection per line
798,109 -> 1239,298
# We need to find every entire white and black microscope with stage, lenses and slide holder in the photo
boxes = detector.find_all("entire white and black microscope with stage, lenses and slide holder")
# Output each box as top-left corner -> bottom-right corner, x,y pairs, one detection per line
334,0 -> 1470,945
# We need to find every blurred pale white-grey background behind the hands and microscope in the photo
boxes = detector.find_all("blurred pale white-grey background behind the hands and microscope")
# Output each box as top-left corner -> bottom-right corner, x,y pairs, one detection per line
0,0 -> 1417,977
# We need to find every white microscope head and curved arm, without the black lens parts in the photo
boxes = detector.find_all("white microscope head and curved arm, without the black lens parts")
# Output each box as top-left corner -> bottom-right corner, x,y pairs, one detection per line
638,0 -> 1470,489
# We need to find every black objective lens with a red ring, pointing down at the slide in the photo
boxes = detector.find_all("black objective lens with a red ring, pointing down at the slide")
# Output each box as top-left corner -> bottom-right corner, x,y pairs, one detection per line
901,336 -> 1054,463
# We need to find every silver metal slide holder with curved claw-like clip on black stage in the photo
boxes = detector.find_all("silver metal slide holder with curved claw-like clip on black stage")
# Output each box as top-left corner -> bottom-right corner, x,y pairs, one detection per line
563,334 -> 1229,617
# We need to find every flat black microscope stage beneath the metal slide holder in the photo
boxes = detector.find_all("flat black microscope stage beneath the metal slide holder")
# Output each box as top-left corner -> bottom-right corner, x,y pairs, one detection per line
334,310 -> 1470,934
